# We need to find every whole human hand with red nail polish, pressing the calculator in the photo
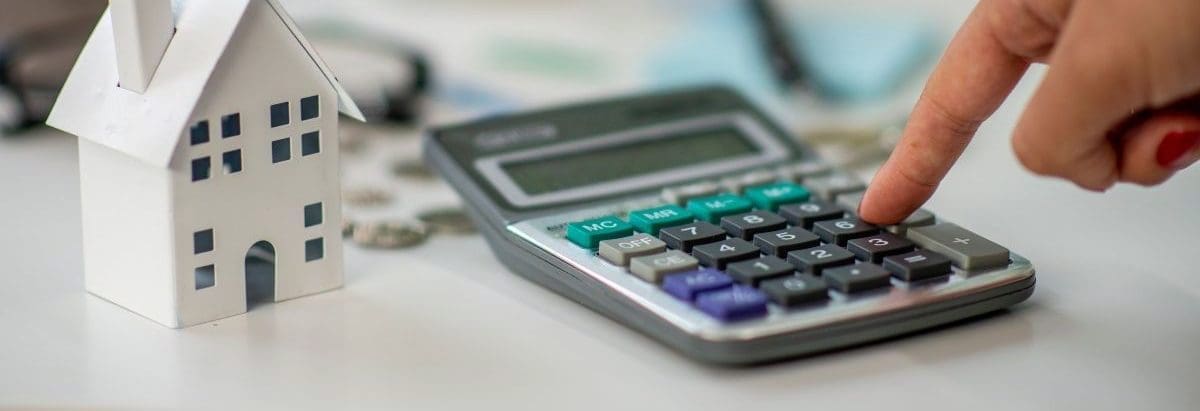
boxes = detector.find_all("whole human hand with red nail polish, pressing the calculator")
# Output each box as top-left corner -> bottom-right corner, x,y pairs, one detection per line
859,0 -> 1200,224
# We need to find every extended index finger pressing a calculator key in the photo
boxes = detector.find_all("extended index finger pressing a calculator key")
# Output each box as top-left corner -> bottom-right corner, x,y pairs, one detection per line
858,1 -> 1046,224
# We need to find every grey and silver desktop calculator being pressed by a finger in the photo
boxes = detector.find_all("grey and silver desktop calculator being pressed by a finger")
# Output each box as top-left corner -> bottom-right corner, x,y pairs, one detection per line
424,87 -> 1034,364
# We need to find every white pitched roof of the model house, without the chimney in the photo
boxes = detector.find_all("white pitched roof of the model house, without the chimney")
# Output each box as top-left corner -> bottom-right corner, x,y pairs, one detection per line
46,0 -> 362,167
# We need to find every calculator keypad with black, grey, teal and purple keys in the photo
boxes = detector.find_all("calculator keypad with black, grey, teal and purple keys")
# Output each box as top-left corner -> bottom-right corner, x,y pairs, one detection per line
566,180 -> 1008,321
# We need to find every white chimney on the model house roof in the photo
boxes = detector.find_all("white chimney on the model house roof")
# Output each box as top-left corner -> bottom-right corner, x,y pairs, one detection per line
108,0 -> 175,94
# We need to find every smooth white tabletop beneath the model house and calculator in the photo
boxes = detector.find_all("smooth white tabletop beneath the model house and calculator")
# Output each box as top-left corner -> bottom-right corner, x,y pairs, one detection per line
0,1 -> 1200,410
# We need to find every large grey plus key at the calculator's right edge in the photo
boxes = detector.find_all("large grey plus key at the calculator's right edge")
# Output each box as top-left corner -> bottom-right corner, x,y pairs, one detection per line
908,222 -> 1008,269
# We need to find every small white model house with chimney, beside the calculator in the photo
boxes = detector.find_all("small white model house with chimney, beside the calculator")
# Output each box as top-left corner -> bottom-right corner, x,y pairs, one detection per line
47,0 -> 362,327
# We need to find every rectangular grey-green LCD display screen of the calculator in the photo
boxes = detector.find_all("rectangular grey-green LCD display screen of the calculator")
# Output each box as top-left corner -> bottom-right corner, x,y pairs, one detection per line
500,126 -> 758,195
